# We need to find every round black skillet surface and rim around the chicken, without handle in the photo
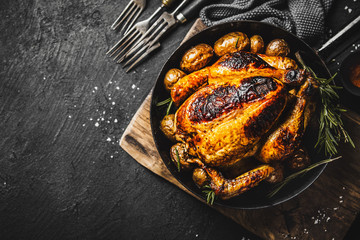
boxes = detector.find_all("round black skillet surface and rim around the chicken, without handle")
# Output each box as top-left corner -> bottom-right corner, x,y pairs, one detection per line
150,21 -> 330,209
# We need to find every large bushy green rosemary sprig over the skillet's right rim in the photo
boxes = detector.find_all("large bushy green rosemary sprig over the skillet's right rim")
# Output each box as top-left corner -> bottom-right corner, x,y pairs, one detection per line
295,52 -> 355,156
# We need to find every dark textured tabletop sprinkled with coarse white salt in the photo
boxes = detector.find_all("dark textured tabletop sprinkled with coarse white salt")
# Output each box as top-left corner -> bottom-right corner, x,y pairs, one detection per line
0,0 -> 360,239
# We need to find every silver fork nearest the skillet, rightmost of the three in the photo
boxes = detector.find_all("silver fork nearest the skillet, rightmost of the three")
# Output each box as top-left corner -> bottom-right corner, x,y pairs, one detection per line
117,0 -> 190,63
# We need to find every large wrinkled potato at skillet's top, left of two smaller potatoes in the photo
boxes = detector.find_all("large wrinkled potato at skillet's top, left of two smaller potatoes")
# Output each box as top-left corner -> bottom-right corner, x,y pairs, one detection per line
214,32 -> 250,56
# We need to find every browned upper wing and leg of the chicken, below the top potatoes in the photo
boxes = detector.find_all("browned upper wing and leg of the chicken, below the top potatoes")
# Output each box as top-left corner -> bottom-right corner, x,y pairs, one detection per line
171,51 -> 297,106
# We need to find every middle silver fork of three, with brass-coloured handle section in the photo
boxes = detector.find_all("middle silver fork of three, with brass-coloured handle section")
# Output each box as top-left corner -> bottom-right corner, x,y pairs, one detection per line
106,0 -> 178,61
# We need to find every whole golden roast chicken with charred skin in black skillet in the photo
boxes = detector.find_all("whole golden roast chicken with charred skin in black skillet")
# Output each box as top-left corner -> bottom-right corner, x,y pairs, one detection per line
162,32 -> 318,199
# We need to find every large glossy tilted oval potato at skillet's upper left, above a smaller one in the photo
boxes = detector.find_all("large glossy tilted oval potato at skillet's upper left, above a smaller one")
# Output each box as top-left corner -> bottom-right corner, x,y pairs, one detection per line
180,43 -> 214,72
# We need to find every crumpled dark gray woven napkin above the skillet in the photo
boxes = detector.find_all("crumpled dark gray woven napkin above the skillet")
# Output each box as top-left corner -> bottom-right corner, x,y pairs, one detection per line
200,0 -> 334,43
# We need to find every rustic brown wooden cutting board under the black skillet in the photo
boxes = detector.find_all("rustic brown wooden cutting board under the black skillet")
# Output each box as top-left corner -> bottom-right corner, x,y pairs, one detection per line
120,20 -> 360,240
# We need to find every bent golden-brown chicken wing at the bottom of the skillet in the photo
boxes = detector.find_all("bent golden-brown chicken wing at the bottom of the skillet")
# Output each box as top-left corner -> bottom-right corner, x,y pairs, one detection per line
205,165 -> 275,200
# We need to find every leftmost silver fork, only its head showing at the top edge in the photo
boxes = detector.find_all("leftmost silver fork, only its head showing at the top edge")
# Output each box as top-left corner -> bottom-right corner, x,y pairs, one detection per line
111,0 -> 146,31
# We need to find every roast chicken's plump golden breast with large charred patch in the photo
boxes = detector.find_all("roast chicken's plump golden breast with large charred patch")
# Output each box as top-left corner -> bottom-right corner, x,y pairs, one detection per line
175,77 -> 287,166
